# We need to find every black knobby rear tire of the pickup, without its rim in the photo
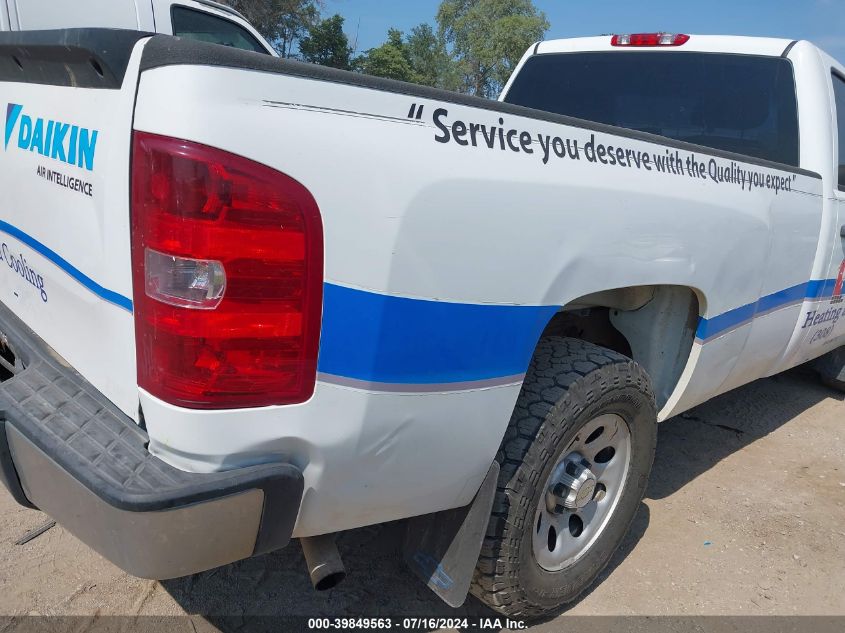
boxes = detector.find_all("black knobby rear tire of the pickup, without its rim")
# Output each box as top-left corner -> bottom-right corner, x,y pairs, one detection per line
470,337 -> 657,617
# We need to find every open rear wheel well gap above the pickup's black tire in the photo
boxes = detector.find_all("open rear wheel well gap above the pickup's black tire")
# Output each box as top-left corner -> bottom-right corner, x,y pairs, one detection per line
543,285 -> 700,408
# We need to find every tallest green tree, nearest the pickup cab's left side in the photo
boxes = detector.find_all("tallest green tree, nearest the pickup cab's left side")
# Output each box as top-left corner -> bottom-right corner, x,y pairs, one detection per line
437,0 -> 549,98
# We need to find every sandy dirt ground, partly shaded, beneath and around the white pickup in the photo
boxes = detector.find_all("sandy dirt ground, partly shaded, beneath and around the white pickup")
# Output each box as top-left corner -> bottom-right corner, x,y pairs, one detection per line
0,362 -> 845,631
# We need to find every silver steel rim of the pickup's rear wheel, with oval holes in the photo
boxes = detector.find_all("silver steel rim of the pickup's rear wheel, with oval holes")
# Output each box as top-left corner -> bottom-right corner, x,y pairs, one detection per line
532,413 -> 631,572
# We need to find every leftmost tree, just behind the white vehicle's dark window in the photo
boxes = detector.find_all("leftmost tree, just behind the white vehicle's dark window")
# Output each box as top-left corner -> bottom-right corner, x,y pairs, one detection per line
228,0 -> 320,57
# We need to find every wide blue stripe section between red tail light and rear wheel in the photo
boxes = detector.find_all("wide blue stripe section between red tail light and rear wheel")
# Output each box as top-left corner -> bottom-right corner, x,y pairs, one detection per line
318,283 -> 558,385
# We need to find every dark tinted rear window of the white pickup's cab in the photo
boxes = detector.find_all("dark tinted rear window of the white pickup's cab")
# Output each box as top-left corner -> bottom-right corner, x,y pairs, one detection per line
505,51 -> 799,167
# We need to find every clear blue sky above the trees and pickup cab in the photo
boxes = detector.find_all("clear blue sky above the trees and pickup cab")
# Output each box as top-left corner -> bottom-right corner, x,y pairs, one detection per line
324,0 -> 845,63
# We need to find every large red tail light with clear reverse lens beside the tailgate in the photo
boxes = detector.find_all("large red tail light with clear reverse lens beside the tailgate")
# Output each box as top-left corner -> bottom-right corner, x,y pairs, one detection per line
132,132 -> 323,409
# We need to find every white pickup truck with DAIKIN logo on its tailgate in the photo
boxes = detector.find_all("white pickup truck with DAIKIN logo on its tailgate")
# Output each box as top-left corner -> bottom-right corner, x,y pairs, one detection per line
0,9 -> 845,617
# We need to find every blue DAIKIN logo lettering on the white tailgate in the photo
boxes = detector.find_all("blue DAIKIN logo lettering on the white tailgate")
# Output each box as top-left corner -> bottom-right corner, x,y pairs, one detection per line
4,103 -> 99,171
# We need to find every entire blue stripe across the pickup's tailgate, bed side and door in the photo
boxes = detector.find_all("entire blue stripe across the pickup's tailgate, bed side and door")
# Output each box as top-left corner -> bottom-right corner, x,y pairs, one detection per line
0,212 -> 836,385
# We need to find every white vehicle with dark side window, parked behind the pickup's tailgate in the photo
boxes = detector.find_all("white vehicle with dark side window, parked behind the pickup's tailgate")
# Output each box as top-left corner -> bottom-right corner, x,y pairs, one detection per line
0,0 -> 276,56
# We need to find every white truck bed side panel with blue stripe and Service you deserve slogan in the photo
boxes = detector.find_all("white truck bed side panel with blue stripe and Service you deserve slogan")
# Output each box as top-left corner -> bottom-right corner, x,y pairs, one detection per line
135,41 -> 821,536
